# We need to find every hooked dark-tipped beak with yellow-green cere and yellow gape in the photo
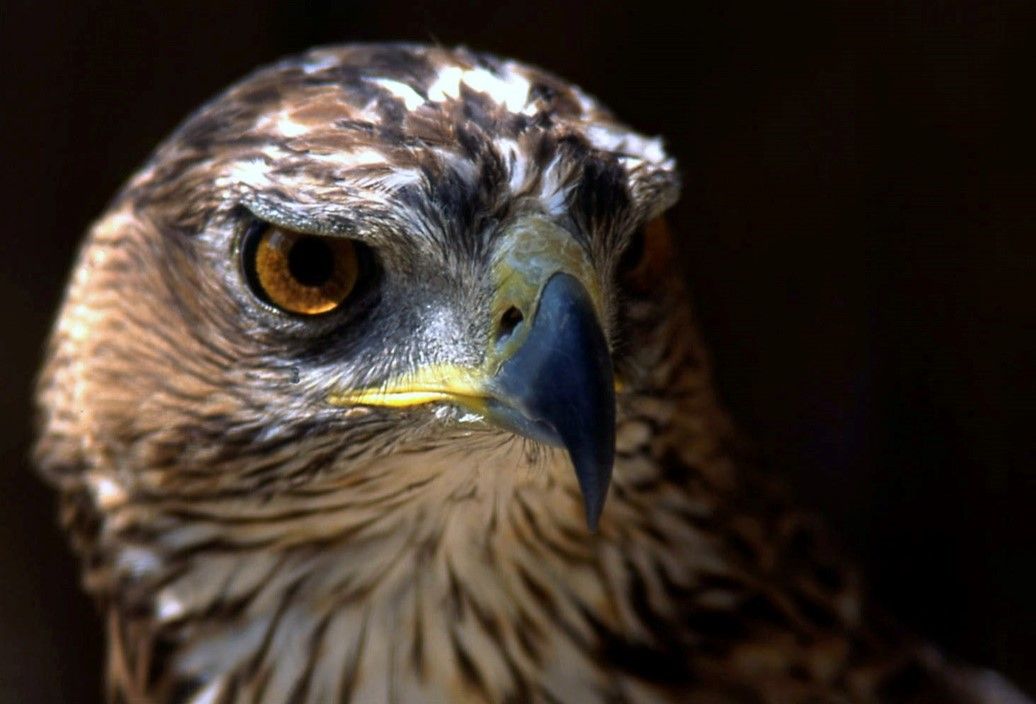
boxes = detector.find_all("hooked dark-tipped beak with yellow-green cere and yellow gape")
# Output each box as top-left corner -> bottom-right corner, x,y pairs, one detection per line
330,218 -> 615,530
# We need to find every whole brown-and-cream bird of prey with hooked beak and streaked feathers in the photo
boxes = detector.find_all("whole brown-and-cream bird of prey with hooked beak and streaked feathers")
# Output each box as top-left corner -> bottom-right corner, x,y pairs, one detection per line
36,45 -> 1024,704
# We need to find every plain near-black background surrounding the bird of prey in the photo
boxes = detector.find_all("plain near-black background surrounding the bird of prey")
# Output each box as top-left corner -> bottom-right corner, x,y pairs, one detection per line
0,0 -> 1036,702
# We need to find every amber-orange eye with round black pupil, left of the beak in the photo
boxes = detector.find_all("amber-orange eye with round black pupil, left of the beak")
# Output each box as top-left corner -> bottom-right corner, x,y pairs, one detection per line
241,225 -> 359,316
